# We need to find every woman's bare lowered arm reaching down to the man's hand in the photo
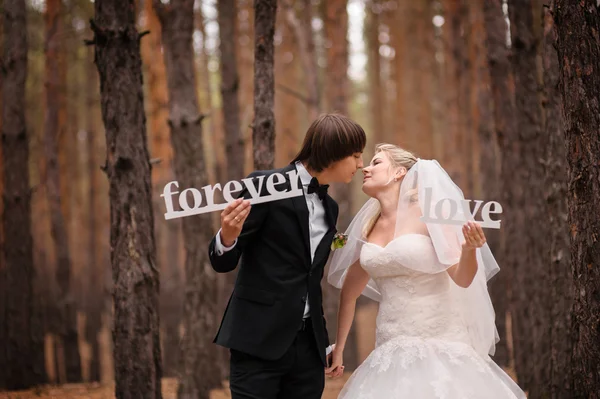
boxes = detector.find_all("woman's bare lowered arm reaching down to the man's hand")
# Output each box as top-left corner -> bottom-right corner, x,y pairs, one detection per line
326,260 -> 369,377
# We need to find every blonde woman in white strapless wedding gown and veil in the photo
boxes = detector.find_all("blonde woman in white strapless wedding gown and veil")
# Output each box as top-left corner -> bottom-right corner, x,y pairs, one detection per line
326,144 -> 525,399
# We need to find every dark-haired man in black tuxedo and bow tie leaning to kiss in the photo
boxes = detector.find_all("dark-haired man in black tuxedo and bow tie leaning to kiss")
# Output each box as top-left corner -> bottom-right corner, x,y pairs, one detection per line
209,114 -> 366,399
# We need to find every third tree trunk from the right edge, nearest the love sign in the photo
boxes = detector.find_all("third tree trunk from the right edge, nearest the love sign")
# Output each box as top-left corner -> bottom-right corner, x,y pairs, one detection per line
503,0 -> 551,390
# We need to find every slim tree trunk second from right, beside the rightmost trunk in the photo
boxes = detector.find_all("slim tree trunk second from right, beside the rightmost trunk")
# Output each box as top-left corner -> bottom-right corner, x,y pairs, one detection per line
542,1 -> 574,398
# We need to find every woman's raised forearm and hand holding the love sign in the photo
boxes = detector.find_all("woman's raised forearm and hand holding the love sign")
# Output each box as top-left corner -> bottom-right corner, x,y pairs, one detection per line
448,222 -> 485,288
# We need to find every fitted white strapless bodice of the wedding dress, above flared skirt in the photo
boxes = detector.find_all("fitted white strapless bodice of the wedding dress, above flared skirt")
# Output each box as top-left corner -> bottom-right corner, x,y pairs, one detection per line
360,234 -> 468,346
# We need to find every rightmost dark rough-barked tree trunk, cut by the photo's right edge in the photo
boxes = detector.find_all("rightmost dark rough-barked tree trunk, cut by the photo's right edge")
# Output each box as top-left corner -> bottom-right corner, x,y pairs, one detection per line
555,0 -> 600,398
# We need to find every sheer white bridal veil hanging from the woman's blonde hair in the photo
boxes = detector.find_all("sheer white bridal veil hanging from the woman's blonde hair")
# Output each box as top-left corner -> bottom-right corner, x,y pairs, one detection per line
327,159 -> 499,355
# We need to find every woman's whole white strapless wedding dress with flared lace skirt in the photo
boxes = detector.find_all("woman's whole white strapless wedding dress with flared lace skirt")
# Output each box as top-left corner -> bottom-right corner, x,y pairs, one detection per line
339,234 -> 525,399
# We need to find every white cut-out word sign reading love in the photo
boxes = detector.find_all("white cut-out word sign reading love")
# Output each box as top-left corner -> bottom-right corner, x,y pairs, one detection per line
421,187 -> 502,229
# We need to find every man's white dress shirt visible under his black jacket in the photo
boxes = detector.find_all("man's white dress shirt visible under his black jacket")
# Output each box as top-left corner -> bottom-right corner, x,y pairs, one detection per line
215,162 -> 329,318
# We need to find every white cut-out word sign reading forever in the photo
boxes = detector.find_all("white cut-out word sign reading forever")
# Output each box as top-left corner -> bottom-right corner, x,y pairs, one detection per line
160,170 -> 303,220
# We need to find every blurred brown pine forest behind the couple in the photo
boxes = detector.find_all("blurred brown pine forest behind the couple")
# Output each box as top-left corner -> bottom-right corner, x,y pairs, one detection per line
0,0 -> 600,398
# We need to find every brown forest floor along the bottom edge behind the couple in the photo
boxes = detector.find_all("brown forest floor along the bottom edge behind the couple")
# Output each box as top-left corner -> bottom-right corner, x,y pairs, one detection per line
0,373 -> 350,399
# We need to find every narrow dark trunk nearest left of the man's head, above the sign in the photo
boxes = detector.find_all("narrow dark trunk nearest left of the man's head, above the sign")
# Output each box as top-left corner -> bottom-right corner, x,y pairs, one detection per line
252,0 -> 277,170
